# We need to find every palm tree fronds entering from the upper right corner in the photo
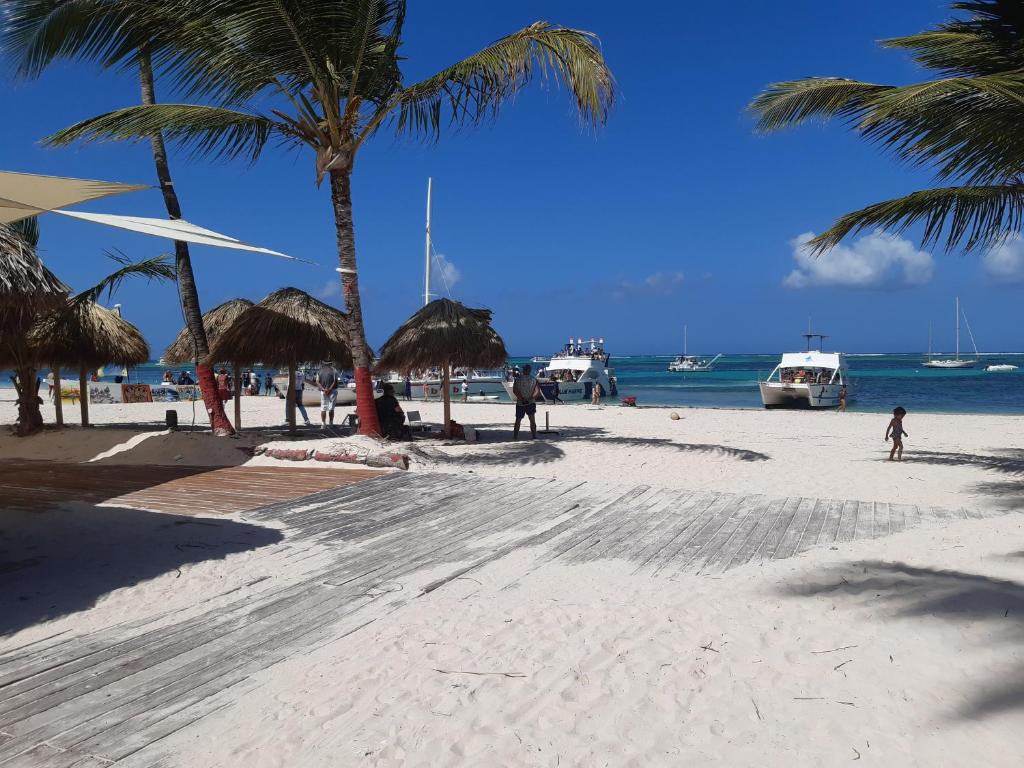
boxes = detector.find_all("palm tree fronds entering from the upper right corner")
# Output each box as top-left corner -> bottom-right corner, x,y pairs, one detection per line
751,0 -> 1024,259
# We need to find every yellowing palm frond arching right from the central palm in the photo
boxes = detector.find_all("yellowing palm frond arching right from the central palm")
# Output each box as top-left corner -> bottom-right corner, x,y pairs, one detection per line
376,22 -> 614,140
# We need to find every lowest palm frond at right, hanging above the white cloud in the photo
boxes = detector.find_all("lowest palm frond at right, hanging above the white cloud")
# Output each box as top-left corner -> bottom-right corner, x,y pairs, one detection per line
808,182 -> 1024,254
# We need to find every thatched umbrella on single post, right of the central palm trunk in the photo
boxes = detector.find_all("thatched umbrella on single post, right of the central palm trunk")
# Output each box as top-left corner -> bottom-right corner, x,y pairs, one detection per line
377,299 -> 508,434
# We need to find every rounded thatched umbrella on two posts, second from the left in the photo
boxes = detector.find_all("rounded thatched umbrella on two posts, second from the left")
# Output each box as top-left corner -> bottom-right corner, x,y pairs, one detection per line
29,299 -> 150,427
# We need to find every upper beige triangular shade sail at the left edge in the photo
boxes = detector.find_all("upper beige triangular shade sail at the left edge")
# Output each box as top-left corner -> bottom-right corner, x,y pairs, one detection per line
0,171 -> 148,224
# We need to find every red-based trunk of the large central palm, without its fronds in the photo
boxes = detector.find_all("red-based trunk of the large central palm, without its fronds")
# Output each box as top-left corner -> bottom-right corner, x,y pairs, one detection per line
331,170 -> 381,435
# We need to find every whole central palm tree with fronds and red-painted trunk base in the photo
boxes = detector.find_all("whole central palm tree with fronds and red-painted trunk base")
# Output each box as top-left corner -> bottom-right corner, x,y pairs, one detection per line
37,0 -> 613,433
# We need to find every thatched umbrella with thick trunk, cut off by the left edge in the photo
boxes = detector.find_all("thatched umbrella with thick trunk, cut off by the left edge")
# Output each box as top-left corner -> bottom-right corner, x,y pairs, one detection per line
0,220 -> 69,435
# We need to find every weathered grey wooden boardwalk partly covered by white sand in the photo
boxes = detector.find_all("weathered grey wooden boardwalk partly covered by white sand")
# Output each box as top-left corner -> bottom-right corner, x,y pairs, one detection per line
0,473 -> 995,768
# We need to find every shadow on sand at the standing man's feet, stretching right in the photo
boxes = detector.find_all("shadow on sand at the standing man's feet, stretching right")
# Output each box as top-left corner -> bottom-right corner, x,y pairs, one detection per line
421,424 -> 771,465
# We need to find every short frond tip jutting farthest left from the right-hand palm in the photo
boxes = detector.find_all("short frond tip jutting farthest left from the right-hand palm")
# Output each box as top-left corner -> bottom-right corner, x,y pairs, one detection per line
748,78 -> 892,133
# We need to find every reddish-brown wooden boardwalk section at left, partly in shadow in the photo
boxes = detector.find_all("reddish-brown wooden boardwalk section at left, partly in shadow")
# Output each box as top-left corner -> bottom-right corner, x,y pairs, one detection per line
0,460 -> 381,515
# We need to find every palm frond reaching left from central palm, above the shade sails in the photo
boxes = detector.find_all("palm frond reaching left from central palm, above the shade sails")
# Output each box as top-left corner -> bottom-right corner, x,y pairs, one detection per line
43,104 -> 285,161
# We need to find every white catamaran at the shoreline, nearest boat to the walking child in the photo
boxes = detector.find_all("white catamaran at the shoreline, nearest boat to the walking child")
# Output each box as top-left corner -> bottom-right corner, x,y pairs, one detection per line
759,332 -> 849,409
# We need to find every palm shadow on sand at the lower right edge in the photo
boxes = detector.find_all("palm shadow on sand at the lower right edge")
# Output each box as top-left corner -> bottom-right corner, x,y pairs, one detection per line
782,553 -> 1024,720
